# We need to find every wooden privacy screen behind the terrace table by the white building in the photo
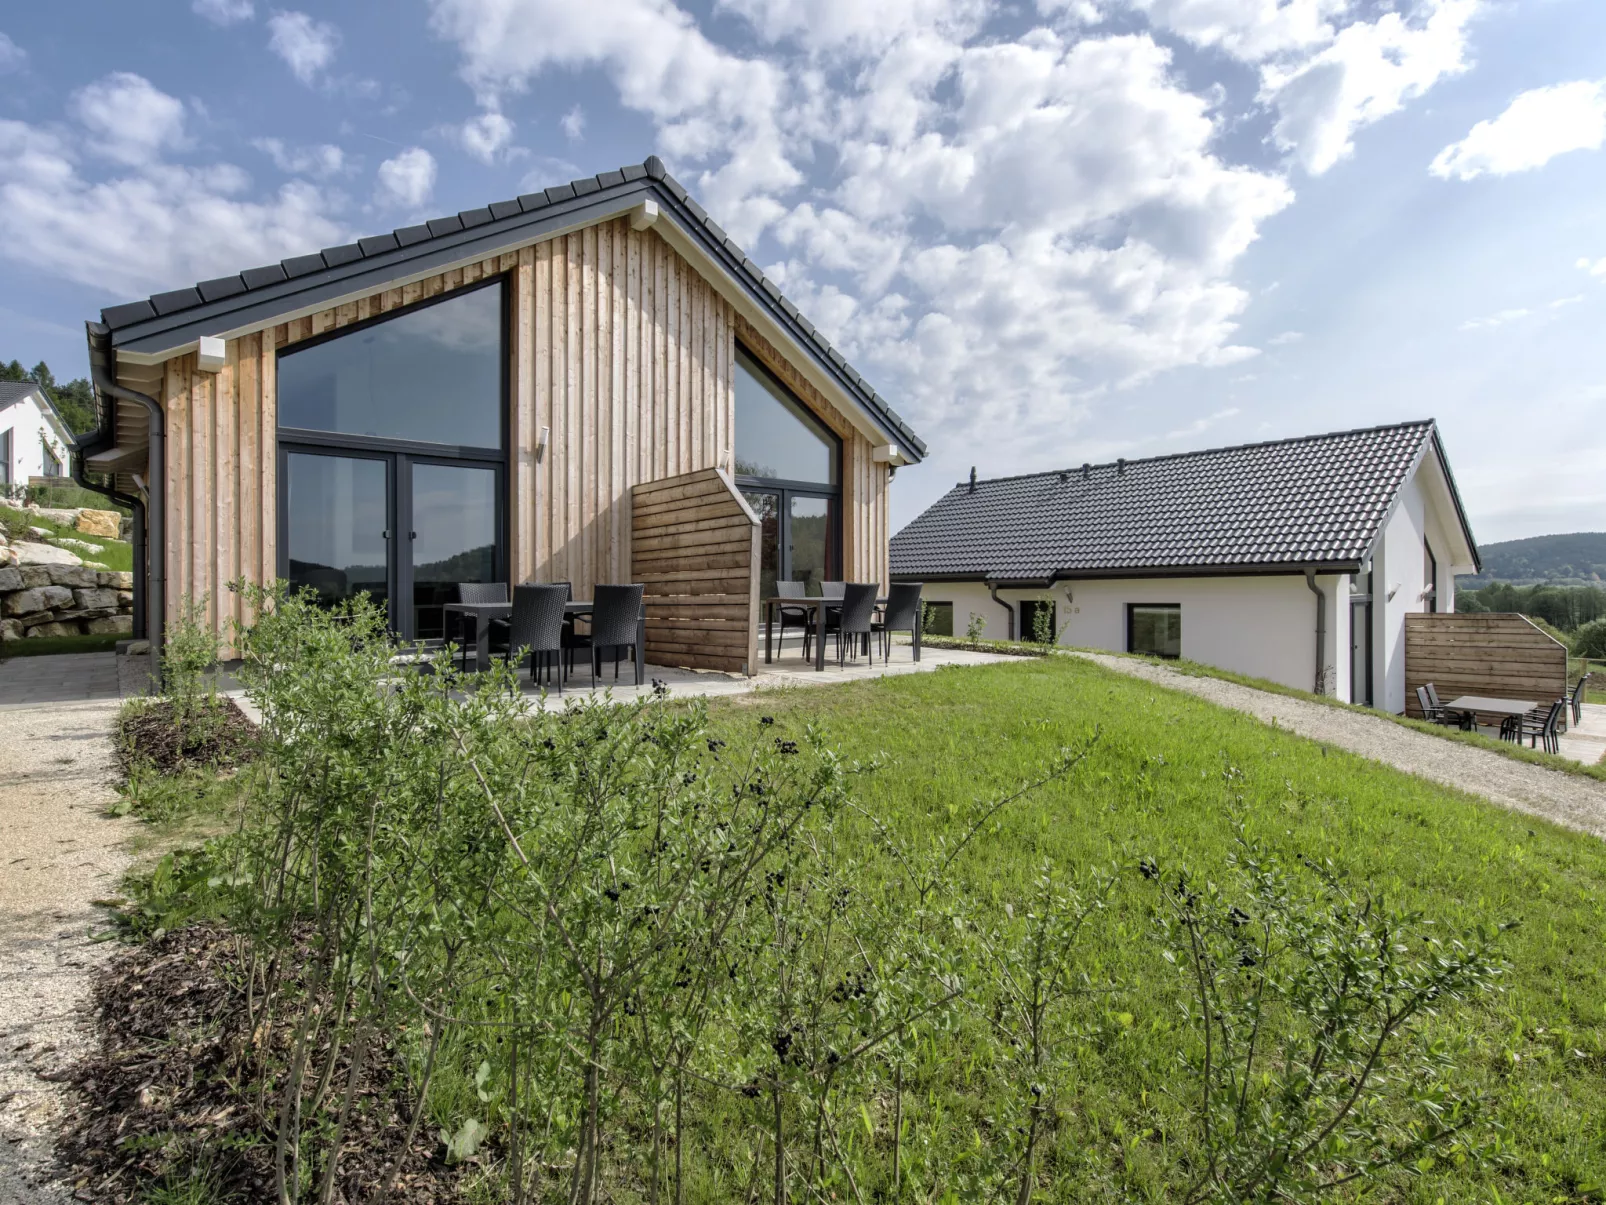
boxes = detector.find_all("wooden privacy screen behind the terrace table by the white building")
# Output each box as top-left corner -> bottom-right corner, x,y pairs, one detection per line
1405,612 -> 1567,718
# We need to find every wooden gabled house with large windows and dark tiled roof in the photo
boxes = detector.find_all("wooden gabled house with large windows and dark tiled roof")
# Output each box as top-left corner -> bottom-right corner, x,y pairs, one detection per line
79,157 -> 925,672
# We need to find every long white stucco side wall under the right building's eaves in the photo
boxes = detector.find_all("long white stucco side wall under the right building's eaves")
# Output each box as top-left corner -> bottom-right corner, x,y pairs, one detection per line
923,575 -> 1349,697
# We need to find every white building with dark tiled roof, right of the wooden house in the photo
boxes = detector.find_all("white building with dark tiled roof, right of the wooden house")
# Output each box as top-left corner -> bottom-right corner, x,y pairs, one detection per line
891,419 -> 1479,712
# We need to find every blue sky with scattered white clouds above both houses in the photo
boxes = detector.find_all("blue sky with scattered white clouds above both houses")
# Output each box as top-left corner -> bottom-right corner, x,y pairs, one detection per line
0,0 -> 1606,540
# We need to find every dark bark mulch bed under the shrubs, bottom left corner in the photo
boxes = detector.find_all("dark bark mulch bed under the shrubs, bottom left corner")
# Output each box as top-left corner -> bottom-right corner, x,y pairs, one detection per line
56,924 -> 464,1205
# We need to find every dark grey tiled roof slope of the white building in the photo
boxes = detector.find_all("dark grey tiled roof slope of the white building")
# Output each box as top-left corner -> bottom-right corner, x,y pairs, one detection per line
891,421 -> 1445,580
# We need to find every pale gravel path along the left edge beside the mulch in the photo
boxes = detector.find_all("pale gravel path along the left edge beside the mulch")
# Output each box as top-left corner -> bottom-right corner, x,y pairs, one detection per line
0,701 -> 133,1205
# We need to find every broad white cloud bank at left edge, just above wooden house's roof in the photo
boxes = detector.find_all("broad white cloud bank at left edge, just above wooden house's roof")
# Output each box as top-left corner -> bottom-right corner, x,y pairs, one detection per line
0,106 -> 345,297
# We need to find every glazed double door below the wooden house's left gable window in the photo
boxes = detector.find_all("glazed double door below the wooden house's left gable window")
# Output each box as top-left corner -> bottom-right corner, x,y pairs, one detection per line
279,447 -> 506,639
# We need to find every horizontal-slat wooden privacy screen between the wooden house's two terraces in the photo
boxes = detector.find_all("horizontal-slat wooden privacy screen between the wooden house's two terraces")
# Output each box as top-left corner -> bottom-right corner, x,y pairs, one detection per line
631,469 -> 758,673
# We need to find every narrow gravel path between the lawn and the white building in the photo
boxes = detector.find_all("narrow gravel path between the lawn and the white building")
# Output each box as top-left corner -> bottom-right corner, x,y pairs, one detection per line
1071,652 -> 1606,837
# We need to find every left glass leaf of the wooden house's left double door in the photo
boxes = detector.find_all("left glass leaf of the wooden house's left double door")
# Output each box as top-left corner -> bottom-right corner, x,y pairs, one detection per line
279,451 -> 395,623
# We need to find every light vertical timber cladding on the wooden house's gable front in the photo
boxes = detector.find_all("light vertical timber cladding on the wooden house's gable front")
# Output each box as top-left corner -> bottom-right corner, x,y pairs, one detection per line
153,219 -> 890,671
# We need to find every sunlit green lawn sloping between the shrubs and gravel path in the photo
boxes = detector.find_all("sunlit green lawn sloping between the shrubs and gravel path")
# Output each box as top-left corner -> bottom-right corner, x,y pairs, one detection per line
715,657 -> 1606,1202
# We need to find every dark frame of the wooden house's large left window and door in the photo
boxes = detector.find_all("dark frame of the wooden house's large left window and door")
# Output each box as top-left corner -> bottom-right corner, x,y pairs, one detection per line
275,272 -> 514,639
